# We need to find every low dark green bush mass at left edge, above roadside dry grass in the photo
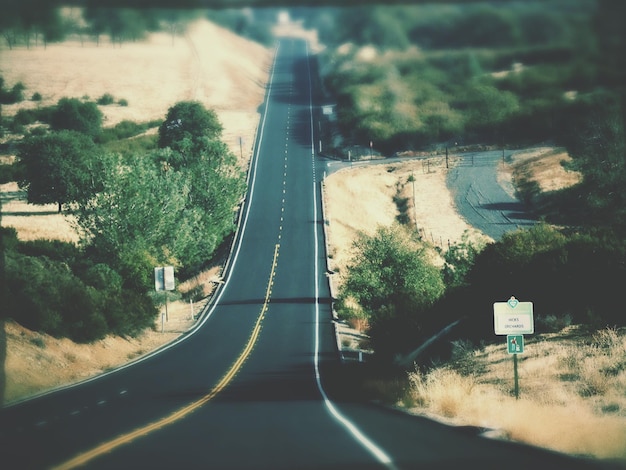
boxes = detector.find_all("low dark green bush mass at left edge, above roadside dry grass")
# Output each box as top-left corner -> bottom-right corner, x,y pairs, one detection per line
5,239 -> 157,343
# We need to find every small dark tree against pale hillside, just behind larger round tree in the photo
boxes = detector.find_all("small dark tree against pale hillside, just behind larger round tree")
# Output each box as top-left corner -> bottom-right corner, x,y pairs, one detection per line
50,98 -> 102,137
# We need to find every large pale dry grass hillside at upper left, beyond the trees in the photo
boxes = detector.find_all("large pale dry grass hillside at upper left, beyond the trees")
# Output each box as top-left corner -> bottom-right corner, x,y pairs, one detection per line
0,20 -> 272,167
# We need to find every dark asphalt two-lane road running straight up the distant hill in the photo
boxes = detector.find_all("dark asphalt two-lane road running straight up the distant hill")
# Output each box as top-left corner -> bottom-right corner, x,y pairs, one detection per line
0,39 -> 616,470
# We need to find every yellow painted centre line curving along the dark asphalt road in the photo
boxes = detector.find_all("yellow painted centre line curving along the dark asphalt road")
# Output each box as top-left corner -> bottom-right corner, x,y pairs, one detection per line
52,244 -> 280,470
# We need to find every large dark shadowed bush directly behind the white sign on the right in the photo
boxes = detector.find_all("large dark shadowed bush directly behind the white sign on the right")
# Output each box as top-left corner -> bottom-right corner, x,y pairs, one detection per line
449,225 -> 626,338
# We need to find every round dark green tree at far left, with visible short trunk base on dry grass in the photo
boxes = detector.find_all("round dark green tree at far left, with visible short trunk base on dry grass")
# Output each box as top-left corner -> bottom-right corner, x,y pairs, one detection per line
17,131 -> 103,212
